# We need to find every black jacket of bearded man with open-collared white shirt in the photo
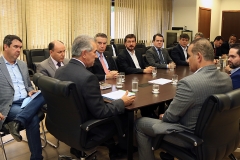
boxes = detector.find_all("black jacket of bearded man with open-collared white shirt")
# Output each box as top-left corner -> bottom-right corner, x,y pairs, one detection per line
117,49 -> 145,74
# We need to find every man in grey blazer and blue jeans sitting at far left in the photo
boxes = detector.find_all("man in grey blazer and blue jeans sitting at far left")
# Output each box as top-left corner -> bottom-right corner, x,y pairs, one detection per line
0,35 -> 45,160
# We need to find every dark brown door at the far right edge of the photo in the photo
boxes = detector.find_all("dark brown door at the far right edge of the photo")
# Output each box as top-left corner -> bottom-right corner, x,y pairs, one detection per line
221,10 -> 240,43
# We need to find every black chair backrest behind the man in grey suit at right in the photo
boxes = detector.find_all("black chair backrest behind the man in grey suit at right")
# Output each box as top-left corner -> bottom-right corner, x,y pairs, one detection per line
194,89 -> 240,160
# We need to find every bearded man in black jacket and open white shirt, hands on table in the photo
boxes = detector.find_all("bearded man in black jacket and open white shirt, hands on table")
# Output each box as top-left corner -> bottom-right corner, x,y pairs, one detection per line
117,34 -> 152,74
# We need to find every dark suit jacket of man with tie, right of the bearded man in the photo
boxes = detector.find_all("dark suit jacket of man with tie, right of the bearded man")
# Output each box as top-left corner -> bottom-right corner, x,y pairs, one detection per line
146,46 -> 172,68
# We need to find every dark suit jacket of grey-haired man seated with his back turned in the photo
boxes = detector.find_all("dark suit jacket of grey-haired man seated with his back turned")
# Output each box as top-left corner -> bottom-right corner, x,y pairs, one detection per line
55,59 -> 125,119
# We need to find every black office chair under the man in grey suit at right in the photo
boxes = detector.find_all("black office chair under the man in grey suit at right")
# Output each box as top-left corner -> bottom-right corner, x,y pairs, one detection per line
153,89 -> 240,160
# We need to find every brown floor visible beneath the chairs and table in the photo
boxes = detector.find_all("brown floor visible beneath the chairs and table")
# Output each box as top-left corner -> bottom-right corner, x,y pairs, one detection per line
0,112 -> 240,160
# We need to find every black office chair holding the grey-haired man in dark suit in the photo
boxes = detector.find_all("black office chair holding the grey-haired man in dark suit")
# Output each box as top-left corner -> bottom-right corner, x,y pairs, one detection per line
34,73 -> 124,159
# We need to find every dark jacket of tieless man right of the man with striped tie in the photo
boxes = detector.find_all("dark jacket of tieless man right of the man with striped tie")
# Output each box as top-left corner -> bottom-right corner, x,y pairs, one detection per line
171,44 -> 189,66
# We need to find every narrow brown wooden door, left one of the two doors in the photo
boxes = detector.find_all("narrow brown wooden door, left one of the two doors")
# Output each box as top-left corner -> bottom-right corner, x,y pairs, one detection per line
198,7 -> 211,39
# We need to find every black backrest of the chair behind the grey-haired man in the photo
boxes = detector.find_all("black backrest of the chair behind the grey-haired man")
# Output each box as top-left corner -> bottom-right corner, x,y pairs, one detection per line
33,73 -> 87,150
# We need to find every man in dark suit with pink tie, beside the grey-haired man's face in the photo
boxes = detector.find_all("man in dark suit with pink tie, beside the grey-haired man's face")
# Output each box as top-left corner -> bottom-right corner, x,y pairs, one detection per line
88,33 -> 118,81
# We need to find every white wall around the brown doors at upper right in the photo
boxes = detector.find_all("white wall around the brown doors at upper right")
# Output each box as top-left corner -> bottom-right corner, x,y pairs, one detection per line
172,0 -> 240,41
